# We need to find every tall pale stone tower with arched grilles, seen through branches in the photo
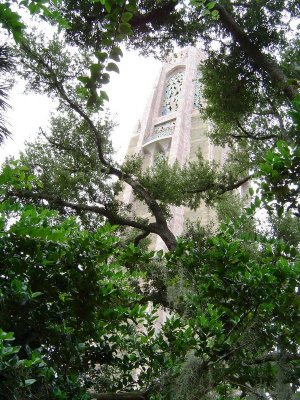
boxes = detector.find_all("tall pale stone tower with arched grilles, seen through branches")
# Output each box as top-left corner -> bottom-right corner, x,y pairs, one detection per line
123,47 -> 226,248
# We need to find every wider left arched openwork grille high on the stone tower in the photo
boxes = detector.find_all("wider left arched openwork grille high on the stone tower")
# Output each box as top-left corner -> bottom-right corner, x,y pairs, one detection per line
161,71 -> 184,115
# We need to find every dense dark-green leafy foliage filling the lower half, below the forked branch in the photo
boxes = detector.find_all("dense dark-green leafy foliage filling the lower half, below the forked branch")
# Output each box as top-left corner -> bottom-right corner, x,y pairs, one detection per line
1,161 -> 299,400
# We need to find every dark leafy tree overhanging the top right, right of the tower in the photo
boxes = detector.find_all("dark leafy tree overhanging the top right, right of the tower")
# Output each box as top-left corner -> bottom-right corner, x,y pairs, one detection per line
57,0 -> 299,214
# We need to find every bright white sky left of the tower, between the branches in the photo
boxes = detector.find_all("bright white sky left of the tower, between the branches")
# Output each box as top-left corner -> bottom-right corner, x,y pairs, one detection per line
0,51 -> 161,161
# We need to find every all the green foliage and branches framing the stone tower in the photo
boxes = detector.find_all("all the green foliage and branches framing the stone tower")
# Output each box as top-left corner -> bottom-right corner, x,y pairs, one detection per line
0,0 -> 300,400
